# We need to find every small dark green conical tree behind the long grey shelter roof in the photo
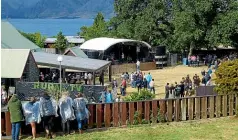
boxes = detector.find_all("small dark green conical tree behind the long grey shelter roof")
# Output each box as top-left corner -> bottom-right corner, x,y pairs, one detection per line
55,31 -> 67,53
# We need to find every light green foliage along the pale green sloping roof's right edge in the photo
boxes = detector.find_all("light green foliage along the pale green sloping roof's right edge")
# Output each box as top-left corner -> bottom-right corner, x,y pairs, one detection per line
19,31 -> 46,48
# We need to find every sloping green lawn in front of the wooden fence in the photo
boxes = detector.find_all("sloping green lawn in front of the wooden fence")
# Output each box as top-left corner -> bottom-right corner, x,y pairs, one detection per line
23,117 -> 238,140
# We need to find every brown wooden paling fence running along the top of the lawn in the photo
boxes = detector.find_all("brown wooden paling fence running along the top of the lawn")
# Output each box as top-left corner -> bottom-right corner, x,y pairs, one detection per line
0,94 -> 238,135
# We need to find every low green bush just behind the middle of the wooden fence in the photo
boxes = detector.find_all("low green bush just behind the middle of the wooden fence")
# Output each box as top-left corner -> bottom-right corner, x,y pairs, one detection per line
124,90 -> 155,101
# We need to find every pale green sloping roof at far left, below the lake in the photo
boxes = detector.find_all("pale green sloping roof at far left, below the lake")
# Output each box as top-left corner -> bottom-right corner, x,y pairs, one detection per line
1,21 -> 40,51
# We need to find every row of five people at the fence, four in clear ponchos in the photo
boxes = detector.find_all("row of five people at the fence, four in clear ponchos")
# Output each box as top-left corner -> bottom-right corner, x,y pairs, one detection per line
8,92 -> 90,140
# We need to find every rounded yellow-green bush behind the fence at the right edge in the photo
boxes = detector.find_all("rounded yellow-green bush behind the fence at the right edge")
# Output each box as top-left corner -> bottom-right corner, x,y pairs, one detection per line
215,59 -> 238,94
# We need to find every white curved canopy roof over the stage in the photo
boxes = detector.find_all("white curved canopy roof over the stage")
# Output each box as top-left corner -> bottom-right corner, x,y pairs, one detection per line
80,37 -> 151,51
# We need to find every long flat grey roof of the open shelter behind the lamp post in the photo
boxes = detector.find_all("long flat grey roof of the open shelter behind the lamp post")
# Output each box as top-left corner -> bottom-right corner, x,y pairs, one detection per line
33,52 -> 111,72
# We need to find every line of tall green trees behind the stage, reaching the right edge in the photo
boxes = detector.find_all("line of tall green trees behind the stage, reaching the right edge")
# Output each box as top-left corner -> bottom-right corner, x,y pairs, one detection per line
79,0 -> 238,53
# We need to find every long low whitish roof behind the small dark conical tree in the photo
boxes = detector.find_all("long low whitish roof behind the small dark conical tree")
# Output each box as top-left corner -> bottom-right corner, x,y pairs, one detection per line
45,36 -> 85,44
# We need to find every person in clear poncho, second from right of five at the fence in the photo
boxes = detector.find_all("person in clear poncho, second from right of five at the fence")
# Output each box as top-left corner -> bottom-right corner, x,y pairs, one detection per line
59,92 -> 75,135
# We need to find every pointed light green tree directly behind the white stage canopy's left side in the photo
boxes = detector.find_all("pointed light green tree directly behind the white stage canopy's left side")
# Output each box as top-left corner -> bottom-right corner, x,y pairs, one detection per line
78,13 -> 108,40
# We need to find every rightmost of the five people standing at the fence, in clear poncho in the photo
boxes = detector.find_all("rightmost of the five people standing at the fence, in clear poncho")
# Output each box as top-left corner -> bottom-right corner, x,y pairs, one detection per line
73,93 -> 90,134
